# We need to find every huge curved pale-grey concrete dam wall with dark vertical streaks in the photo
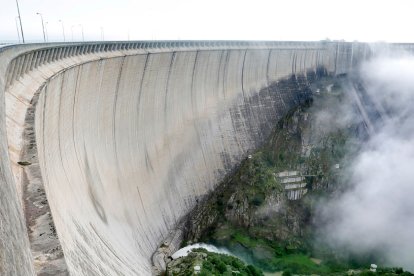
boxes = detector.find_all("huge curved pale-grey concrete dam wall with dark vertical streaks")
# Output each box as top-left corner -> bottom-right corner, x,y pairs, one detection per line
0,41 -> 376,275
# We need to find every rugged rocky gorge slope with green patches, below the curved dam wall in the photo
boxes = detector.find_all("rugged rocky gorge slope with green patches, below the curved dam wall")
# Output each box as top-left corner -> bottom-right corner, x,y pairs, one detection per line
181,77 -> 364,272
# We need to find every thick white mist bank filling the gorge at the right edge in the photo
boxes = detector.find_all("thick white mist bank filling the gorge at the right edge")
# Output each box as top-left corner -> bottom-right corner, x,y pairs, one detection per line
320,52 -> 414,271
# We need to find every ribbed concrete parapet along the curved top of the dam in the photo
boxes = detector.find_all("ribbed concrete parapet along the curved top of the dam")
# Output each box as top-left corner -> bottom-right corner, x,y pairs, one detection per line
1,41 -> 326,89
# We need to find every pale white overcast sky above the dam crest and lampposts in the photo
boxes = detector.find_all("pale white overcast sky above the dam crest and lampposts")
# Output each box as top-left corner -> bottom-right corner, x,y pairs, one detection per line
0,0 -> 414,42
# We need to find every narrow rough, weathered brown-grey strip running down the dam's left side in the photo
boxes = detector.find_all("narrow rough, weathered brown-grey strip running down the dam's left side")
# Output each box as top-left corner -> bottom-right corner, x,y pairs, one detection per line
20,90 -> 68,276
